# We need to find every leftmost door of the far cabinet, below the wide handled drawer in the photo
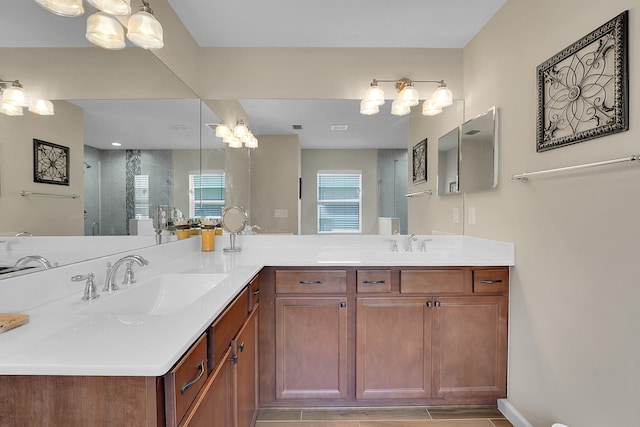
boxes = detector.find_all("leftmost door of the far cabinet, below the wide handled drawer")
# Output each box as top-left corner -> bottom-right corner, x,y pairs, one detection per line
275,297 -> 348,399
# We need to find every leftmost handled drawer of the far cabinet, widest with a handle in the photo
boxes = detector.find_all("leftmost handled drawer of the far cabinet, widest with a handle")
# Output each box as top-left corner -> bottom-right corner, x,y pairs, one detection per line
276,270 -> 347,294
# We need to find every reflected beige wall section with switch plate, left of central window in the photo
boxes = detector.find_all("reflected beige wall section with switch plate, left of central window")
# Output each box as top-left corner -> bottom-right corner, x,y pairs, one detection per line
250,135 -> 300,234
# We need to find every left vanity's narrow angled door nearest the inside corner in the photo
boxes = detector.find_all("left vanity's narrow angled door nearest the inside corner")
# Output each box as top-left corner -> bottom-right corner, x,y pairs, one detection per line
233,306 -> 258,427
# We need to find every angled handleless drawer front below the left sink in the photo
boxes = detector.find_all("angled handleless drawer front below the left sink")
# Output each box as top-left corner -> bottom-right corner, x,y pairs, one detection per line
208,287 -> 249,370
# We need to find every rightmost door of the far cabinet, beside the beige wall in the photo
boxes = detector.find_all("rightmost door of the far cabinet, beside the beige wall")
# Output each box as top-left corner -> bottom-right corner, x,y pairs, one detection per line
433,296 -> 507,398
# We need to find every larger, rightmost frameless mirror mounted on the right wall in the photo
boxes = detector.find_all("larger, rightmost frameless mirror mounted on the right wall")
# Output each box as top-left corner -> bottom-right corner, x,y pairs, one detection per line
458,107 -> 498,193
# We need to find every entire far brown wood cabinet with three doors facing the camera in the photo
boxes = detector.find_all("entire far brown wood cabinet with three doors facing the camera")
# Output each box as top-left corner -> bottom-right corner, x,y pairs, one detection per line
260,267 -> 509,407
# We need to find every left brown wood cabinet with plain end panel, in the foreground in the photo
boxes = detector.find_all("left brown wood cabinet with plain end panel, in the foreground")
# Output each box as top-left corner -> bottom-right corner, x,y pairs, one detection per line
0,276 -> 260,427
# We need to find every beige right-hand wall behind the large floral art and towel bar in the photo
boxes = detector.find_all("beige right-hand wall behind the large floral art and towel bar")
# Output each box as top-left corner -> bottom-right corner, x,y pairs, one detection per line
452,0 -> 640,427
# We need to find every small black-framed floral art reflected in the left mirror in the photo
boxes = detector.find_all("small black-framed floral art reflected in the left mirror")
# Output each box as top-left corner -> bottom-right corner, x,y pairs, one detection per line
33,139 -> 69,185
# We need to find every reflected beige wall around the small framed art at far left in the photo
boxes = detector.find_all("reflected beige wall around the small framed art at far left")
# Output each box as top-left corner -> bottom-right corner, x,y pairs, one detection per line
0,101 -> 84,236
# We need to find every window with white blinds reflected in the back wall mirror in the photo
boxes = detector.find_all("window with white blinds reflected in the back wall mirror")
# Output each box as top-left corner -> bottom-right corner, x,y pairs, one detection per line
318,171 -> 362,233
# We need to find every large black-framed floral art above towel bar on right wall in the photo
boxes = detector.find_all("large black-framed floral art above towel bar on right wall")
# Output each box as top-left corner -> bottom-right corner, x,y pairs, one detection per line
536,11 -> 629,152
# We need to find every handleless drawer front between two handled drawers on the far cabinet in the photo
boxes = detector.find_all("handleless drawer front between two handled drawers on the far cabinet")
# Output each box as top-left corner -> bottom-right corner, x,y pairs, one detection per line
400,269 -> 464,294
